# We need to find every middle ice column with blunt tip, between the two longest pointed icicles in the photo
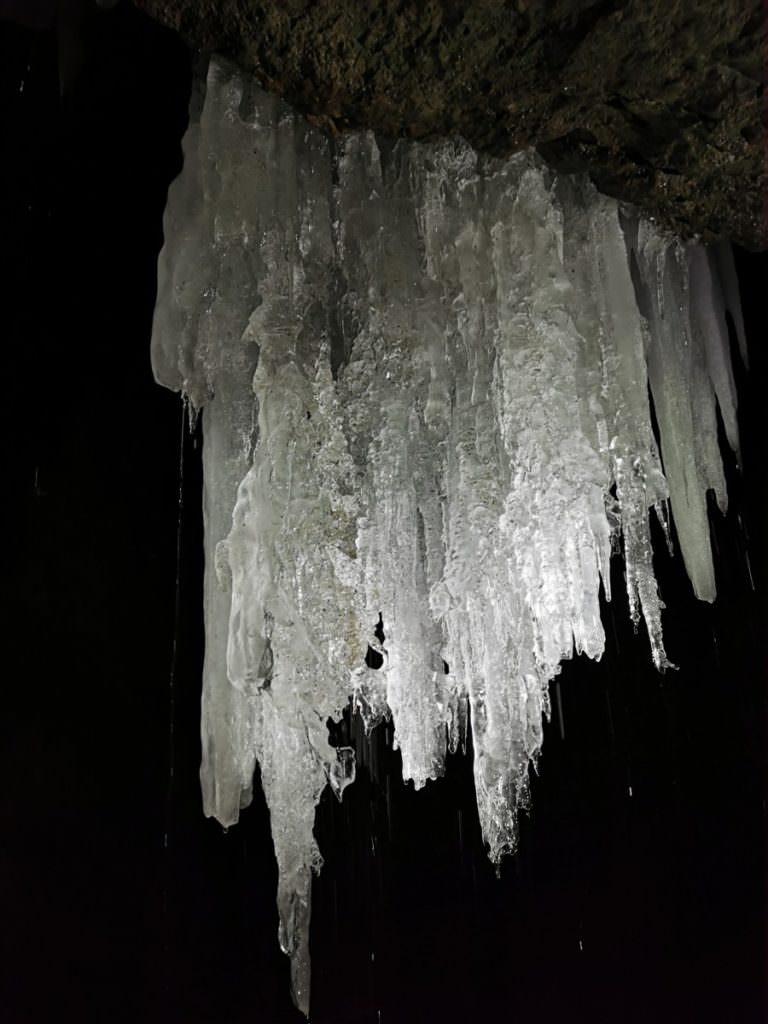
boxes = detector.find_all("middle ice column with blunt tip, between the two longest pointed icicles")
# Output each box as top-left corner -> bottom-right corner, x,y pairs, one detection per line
337,135 -> 456,787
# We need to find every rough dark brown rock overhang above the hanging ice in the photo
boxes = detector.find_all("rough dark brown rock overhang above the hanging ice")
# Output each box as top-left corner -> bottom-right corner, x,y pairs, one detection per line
136,0 -> 768,249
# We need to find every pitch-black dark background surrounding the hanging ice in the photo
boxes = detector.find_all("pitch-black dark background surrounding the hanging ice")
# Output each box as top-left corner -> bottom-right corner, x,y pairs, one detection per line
0,3 -> 768,1024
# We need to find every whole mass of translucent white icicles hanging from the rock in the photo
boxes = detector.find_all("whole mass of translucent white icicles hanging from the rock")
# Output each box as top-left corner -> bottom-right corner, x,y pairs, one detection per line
153,61 -> 742,1013
